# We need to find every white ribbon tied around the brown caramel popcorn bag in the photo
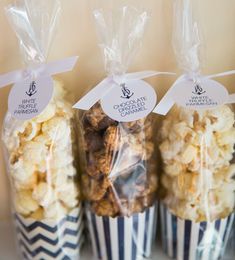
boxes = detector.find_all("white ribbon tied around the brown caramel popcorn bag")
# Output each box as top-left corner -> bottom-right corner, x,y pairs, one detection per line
73,70 -> 175,110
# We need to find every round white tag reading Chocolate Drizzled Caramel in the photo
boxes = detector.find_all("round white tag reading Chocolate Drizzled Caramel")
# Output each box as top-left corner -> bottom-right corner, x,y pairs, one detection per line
101,80 -> 157,122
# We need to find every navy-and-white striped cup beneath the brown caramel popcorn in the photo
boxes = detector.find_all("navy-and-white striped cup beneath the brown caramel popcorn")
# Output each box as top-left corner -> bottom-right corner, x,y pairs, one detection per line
86,205 -> 157,260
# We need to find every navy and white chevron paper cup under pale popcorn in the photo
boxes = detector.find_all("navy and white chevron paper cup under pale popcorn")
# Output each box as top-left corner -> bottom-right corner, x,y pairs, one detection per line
15,208 -> 84,260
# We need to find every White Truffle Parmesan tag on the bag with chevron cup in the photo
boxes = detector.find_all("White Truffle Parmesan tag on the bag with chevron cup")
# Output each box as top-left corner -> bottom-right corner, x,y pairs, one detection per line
8,77 -> 54,120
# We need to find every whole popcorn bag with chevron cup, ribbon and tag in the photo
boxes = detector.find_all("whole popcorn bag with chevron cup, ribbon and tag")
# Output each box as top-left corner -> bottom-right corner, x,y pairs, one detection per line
0,0 -> 83,260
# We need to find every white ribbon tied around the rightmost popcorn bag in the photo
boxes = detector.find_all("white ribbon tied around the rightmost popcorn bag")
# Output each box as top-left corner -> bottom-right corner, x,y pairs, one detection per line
153,70 -> 235,115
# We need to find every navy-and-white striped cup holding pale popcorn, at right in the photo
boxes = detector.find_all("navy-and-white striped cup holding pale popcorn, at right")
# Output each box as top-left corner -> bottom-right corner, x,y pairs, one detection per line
160,204 -> 234,260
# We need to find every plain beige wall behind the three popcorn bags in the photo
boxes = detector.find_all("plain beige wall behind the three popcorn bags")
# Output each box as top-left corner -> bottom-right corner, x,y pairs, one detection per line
0,0 -> 235,220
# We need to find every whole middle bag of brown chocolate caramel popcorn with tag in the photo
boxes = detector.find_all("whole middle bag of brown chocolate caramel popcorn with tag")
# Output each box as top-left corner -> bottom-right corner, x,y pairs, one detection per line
74,6 -> 167,260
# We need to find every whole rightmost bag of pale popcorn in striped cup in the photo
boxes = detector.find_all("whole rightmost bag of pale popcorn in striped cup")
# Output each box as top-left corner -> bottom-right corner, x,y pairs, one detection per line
154,0 -> 235,260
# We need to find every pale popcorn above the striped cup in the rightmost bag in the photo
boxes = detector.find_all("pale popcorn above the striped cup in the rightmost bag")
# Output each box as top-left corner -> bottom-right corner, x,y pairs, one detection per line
160,105 -> 235,222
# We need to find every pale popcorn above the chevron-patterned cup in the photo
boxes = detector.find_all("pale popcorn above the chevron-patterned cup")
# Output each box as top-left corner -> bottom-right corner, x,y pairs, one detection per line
3,81 -> 79,220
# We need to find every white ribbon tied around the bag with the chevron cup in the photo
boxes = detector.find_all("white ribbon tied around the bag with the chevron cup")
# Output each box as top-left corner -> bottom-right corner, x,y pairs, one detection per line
0,56 -> 78,88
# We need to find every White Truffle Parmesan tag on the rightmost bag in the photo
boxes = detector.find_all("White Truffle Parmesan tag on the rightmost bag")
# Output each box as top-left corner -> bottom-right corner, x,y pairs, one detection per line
172,78 -> 229,110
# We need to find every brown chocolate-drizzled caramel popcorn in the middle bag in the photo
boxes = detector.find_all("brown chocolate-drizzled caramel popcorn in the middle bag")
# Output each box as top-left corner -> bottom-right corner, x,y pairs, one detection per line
80,103 -> 157,217
